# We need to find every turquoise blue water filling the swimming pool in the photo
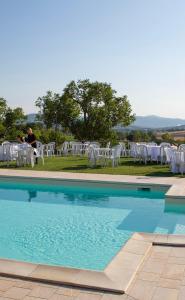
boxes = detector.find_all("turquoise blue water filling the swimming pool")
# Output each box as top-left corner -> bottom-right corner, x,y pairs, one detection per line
0,181 -> 185,270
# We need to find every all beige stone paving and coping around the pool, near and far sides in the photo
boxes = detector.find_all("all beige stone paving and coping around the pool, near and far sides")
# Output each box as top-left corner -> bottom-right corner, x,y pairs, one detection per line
0,169 -> 185,300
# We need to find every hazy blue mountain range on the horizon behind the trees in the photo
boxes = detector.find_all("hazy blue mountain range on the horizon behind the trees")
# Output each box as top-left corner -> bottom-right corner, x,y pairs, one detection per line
27,113 -> 185,129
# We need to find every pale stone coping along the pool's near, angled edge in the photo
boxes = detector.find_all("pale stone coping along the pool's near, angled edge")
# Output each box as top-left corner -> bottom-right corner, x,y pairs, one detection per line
0,232 -> 185,294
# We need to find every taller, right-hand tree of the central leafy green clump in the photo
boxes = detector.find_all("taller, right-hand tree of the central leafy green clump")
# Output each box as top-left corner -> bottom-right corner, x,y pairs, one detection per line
63,79 -> 135,140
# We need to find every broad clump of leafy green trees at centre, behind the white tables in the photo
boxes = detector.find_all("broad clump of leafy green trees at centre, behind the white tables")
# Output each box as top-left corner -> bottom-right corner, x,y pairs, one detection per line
36,79 -> 135,140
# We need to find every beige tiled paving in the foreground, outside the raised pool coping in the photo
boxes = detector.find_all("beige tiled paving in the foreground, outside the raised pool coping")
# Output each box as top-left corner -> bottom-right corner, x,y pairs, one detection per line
0,246 -> 185,300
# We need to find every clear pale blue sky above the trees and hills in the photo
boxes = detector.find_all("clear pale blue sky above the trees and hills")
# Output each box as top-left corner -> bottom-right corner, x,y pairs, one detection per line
0,0 -> 185,118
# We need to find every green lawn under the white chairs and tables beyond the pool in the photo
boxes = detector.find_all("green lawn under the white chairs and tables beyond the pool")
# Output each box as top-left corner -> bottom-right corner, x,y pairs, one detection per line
0,156 -> 176,176
